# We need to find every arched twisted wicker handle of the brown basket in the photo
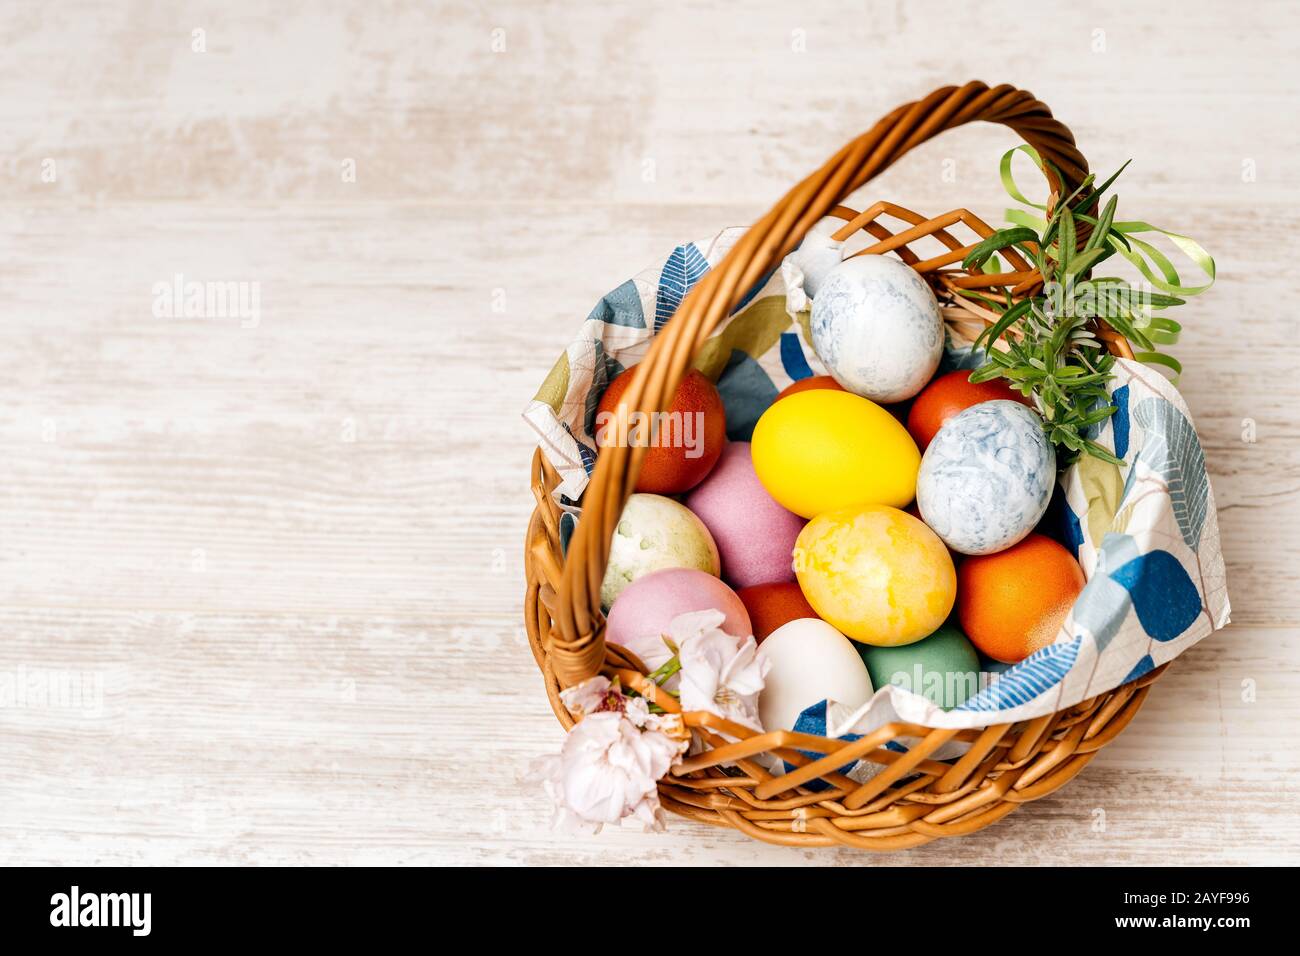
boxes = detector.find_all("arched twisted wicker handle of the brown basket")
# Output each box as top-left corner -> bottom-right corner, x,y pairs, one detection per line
550,81 -> 1088,687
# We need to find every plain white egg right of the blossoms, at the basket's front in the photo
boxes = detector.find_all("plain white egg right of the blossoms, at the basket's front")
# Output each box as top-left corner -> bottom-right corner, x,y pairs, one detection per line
758,618 -> 872,730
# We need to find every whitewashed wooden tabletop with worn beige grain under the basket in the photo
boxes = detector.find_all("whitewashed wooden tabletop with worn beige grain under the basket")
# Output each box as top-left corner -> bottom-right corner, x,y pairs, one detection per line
0,0 -> 1300,865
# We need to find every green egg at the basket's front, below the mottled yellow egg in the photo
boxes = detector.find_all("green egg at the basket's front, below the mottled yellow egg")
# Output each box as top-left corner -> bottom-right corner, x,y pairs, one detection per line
854,624 -> 979,710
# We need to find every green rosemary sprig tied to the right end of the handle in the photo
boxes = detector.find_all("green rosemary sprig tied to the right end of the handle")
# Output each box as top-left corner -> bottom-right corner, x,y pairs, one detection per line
962,163 -> 1183,464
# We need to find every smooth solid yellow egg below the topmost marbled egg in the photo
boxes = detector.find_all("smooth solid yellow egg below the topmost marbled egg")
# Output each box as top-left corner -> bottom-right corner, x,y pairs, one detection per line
751,389 -> 920,518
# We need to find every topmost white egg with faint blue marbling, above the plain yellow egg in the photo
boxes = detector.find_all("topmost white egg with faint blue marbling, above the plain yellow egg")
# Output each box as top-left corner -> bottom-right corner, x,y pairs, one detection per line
811,255 -> 944,402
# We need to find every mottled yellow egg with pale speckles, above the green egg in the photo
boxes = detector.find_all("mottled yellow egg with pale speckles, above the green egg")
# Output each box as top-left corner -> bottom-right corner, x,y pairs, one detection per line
794,505 -> 957,648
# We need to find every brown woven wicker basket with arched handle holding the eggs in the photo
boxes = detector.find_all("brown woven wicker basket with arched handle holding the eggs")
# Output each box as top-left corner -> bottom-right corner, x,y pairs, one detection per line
524,82 -> 1164,849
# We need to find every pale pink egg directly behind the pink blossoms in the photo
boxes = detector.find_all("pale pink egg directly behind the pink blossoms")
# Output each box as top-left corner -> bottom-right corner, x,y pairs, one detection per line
605,567 -> 754,670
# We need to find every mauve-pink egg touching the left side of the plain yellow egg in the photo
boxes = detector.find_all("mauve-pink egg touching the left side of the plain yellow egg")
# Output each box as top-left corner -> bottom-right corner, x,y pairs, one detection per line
686,441 -> 805,588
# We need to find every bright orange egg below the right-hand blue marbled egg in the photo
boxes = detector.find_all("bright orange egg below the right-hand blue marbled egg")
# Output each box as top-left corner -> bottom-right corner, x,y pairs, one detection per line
957,535 -> 1086,663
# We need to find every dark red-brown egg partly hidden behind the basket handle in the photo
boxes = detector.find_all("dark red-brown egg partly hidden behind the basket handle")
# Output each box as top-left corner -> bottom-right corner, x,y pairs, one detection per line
595,365 -> 727,494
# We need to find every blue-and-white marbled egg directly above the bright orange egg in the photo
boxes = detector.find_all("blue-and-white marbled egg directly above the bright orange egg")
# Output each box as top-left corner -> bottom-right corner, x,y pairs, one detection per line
917,401 -> 1056,554
